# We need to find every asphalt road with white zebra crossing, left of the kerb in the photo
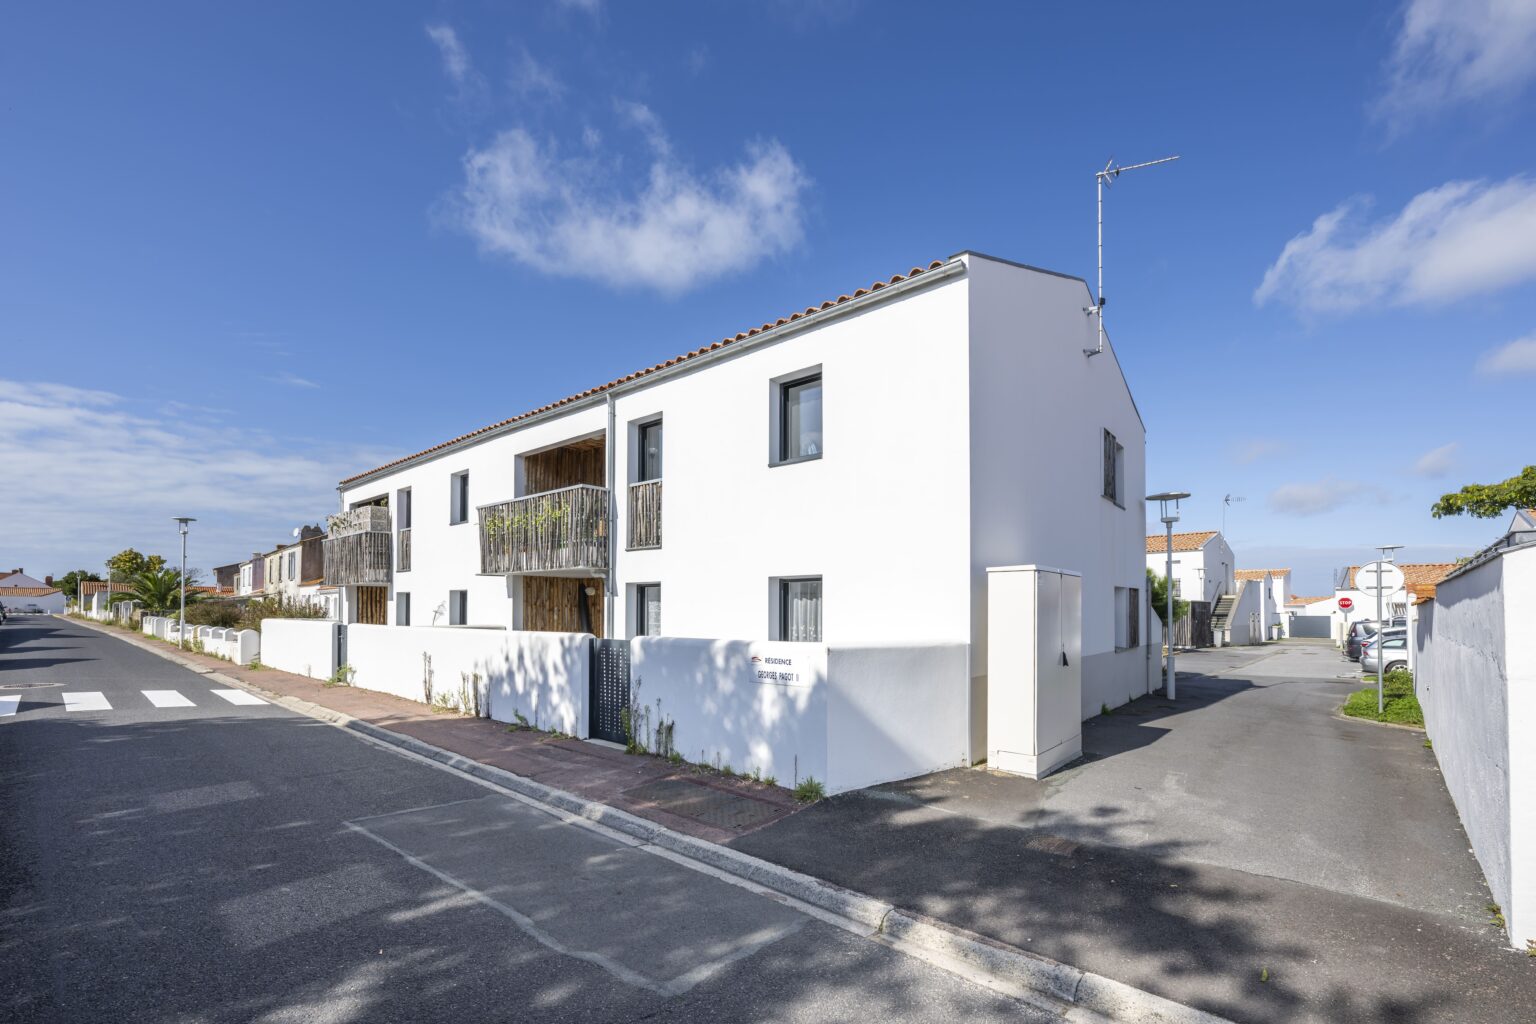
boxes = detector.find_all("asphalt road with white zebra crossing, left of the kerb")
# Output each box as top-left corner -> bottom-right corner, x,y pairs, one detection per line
0,617 -> 1048,1024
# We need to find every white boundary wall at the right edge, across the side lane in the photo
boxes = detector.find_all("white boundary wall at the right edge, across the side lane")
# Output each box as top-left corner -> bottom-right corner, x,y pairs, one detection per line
1415,547 -> 1536,949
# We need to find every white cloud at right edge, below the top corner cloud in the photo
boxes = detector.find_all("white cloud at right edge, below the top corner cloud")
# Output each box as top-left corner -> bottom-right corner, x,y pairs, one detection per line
1253,175 -> 1536,313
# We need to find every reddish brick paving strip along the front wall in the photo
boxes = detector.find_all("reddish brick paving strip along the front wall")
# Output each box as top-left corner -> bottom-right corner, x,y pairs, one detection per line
74,619 -> 800,843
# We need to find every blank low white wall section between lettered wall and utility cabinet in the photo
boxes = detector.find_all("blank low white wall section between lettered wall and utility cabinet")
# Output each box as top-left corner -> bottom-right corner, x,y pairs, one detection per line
823,643 -> 971,792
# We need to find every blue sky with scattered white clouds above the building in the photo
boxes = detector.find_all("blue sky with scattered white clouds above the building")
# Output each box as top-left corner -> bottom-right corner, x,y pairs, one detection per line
0,0 -> 1536,593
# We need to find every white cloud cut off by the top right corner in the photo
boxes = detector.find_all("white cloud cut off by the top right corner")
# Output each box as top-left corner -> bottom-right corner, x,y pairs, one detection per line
1376,0 -> 1536,126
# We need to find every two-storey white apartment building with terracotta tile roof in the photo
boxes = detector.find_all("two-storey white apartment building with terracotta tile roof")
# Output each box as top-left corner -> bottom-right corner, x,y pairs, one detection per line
326,252 -> 1148,751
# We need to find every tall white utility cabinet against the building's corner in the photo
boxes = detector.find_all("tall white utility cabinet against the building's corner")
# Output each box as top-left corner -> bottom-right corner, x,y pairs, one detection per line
986,565 -> 1083,778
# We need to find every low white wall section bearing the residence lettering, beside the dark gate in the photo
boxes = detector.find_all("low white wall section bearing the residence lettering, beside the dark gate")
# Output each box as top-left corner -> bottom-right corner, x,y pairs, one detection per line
630,637 -> 835,791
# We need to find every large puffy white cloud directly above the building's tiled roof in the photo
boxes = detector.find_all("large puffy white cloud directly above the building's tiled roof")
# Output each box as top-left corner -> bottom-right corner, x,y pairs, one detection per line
445,112 -> 808,293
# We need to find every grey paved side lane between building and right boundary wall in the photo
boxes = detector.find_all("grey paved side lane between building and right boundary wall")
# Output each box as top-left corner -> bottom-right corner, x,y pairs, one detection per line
731,645 -> 1536,1024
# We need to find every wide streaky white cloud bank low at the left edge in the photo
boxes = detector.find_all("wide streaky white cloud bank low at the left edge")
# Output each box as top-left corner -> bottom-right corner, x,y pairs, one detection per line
0,381 -> 389,573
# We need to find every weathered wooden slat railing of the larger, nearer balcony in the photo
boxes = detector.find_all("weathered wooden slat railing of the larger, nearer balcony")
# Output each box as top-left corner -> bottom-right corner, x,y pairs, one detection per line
479,484 -> 608,576
